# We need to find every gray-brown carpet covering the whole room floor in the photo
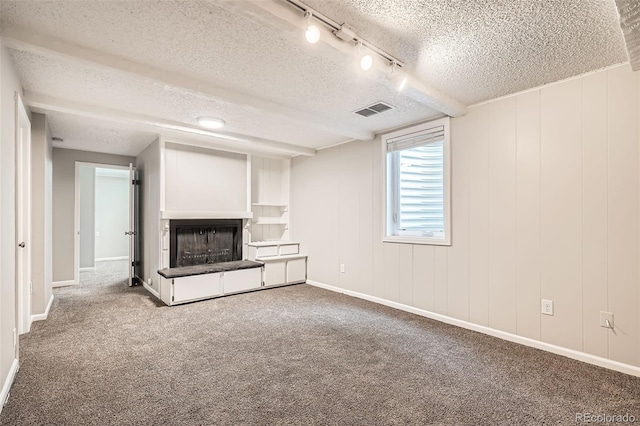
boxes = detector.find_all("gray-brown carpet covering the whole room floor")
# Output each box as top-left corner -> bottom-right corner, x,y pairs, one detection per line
0,265 -> 640,425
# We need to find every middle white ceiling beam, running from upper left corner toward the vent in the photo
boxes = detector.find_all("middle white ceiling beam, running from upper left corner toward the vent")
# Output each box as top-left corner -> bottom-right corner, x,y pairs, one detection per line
0,27 -> 374,140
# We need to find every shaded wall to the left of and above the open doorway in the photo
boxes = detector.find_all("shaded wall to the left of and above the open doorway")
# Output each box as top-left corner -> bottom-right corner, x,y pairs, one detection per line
53,148 -> 135,282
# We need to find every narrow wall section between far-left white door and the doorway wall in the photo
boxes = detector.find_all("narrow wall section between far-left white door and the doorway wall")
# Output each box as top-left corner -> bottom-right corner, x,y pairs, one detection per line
31,114 -> 53,319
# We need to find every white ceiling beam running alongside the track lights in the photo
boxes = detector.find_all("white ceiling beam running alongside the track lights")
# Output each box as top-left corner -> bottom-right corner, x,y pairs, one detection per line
239,0 -> 467,117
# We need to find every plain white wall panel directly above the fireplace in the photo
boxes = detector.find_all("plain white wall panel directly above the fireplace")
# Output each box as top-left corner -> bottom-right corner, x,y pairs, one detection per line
164,144 -> 247,211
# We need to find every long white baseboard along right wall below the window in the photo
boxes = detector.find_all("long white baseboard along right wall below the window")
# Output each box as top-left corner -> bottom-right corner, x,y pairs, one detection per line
307,280 -> 640,377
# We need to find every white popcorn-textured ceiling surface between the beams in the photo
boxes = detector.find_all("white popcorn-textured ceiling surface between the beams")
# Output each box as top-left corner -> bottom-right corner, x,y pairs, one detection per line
0,0 -> 626,155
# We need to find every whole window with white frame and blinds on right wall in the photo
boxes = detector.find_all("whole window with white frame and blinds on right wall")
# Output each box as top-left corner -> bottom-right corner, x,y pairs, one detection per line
382,118 -> 451,245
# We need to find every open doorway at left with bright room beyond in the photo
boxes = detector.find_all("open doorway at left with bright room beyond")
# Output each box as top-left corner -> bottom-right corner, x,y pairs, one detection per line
76,163 -> 131,285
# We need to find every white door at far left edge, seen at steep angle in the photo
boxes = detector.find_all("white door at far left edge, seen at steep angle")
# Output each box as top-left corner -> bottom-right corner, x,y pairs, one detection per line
15,93 -> 31,334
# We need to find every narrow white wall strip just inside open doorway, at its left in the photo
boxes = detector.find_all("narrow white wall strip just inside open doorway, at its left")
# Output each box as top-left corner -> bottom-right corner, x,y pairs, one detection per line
78,165 -> 96,268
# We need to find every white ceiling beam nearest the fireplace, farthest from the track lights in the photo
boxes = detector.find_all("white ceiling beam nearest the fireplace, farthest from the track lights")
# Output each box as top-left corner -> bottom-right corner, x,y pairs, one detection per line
24,91 -> 316,156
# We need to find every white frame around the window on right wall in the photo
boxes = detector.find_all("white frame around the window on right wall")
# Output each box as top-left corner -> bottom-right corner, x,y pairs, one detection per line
381,117 -> 451,246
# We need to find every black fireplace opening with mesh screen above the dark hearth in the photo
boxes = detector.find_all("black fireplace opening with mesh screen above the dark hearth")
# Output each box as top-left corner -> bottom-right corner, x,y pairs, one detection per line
169,219 -> 242,268
